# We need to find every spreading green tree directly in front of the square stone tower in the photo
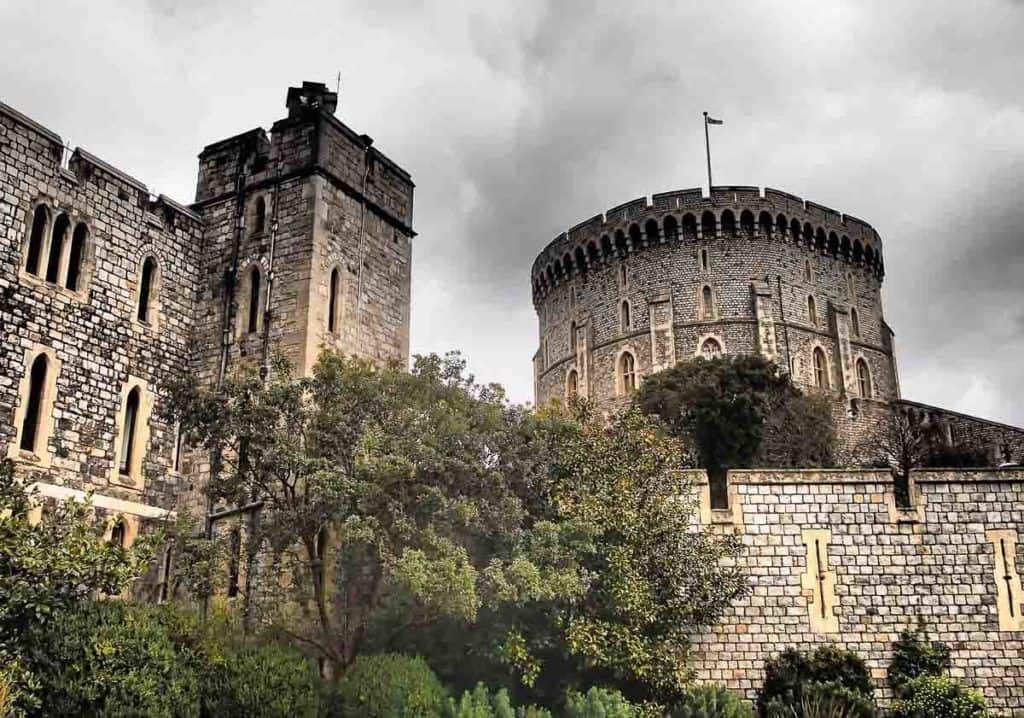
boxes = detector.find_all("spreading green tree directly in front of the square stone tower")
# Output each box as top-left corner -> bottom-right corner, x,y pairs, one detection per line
169,353 -> 561,668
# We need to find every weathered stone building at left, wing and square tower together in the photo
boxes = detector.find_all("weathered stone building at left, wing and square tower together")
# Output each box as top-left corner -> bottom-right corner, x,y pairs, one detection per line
0,83 -> 415,553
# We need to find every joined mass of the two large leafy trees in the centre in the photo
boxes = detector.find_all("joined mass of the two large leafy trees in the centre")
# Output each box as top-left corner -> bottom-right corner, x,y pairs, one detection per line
165,354 -> 745,705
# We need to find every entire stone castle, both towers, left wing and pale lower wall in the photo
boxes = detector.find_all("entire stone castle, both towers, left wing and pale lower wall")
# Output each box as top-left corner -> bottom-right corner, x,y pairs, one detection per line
0,83 -> 1024,715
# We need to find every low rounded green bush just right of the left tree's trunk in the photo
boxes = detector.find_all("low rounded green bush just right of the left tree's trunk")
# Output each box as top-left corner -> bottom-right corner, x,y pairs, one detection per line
327,653 -> 445,718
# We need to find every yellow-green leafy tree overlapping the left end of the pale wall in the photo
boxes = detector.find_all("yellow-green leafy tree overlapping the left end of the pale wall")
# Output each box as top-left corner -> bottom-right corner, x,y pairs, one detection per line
495,405 -> 746,705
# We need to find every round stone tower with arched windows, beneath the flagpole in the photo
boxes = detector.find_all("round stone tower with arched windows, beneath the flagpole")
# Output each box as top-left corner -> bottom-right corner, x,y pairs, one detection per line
531,186 -> 899,445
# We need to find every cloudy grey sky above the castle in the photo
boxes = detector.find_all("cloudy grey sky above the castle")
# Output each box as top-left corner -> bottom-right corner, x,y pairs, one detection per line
0,0 -> 1024,424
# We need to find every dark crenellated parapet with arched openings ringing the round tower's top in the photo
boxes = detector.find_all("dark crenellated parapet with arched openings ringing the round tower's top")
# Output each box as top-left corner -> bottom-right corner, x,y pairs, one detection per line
531,186 -> 885,302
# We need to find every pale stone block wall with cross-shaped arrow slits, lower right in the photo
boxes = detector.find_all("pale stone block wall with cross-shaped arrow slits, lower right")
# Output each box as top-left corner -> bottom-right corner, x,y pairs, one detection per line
690,469 -> 1024,715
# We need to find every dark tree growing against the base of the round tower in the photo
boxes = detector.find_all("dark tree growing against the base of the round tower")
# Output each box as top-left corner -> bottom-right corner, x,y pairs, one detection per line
637,355 -> 836,505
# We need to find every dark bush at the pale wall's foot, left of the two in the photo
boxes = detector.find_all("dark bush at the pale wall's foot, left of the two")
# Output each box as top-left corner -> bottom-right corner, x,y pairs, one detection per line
758,645 -> 874,718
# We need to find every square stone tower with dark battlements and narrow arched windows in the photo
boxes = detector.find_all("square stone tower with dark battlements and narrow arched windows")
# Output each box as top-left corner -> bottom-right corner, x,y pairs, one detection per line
194,82 -> 415,383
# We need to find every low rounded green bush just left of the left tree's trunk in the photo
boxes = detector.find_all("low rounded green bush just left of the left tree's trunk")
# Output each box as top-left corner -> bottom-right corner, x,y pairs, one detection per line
204,643 -> 321,718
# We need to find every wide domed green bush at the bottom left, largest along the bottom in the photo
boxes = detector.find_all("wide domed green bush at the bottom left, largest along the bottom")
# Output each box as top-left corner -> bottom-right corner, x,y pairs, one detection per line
27,601 -> 202,718
